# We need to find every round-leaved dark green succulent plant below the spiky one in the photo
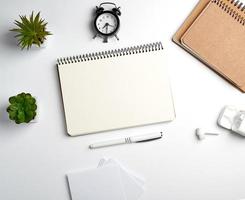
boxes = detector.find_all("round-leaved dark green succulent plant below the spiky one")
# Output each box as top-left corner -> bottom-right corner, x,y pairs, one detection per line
7,93 -> 37,124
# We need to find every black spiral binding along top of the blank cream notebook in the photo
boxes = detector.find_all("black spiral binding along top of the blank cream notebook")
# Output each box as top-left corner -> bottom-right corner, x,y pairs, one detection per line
57,42 -> 163,65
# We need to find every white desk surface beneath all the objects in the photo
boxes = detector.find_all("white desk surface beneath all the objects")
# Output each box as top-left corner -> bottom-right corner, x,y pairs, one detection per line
0,0 -> 245,200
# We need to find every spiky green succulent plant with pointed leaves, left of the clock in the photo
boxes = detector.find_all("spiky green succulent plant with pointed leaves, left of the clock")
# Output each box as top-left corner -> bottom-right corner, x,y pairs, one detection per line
10,12 -> 52,49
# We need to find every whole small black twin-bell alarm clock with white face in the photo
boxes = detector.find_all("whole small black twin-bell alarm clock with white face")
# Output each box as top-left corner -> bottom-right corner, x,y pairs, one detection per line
94,2 -> 121,42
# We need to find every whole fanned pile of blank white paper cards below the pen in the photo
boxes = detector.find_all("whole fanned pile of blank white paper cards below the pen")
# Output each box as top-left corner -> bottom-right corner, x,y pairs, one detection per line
68,159 -> 144,200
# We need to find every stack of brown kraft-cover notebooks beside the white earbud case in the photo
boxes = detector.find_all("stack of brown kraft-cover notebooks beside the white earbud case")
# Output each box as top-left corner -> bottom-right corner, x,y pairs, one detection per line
173,0 -> 245,92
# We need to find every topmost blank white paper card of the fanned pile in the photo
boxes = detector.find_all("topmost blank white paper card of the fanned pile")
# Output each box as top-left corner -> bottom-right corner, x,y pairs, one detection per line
67,165 -> 126,200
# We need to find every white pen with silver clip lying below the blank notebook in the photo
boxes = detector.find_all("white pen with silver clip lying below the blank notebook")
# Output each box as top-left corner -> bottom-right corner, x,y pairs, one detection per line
89,132 -> 163,149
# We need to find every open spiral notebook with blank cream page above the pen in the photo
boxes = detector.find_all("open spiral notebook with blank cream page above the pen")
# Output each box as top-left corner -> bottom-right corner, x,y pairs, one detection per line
58,42 -> 175,136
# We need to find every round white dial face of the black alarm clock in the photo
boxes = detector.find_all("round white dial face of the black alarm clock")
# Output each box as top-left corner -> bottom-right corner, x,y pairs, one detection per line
95,11 -> 119,36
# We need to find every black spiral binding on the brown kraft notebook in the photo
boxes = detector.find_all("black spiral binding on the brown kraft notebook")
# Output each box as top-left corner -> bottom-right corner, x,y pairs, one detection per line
212,0 -> 245,26
